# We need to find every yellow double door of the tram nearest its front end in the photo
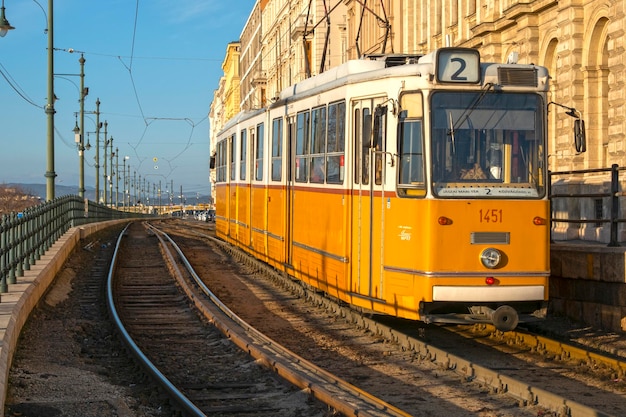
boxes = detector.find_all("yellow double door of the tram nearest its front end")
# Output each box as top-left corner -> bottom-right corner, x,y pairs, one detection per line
351,98 -> 387,304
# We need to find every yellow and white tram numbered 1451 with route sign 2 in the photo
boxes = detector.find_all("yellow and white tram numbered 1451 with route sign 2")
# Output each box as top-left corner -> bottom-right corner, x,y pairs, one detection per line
214,48 -> 572,331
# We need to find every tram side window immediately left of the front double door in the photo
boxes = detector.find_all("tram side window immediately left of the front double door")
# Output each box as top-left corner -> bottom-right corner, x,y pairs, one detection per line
326,101 -> 346,184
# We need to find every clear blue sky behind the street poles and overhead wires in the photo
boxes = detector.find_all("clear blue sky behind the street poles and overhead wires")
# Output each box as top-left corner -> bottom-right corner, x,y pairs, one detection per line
0,0 -> 254,196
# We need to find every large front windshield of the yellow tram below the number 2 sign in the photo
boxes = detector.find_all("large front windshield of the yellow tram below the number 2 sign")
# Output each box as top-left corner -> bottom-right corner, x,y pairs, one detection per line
431,89 -> 545,198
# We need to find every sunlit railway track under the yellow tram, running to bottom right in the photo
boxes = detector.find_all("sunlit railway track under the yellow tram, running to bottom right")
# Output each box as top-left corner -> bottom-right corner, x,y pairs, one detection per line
157,218 -> 626,417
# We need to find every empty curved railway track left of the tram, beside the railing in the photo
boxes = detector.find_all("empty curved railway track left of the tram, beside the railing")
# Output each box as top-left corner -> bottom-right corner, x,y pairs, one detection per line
108,223 -> 407,416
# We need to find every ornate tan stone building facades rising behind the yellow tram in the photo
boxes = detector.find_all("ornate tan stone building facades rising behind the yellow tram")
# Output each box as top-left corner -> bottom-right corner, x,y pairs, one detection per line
211,0 -> 626,242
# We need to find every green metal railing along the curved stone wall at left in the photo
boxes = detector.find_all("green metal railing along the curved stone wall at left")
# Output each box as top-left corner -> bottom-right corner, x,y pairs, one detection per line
0,195 -> 143,293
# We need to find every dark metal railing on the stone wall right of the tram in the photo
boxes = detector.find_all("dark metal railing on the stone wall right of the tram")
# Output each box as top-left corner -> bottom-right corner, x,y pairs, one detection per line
549,164 -> 626,247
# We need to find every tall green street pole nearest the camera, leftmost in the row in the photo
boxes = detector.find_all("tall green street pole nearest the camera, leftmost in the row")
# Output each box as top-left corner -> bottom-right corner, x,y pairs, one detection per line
45,0 -> 57,201
